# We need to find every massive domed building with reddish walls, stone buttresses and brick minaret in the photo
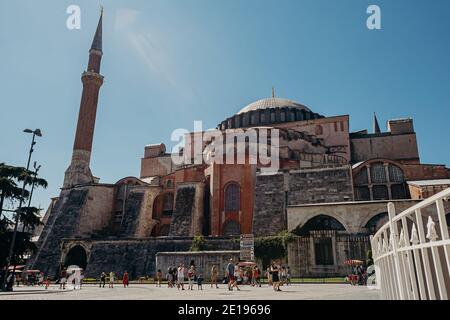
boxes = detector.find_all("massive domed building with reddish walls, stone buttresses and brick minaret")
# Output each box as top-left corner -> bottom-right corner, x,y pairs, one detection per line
28,11 -> 450,277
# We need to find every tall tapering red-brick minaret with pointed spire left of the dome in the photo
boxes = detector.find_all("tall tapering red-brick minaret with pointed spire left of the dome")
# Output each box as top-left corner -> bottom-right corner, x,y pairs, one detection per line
64,10 -> 103,188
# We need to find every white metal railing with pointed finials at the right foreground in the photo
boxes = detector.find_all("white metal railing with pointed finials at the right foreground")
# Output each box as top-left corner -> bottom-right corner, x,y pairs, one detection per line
371,189 -> 450,300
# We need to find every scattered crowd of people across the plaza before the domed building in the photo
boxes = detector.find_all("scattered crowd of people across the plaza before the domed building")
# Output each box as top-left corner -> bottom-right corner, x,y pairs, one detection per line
7,259 -> 367,291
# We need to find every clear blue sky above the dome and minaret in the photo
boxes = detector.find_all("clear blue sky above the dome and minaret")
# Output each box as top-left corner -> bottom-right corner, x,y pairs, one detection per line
0,0 -> 450,212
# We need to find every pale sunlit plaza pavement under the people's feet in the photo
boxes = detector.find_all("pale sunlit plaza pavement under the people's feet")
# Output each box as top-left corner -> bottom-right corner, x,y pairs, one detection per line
0,284 -> 380,300
